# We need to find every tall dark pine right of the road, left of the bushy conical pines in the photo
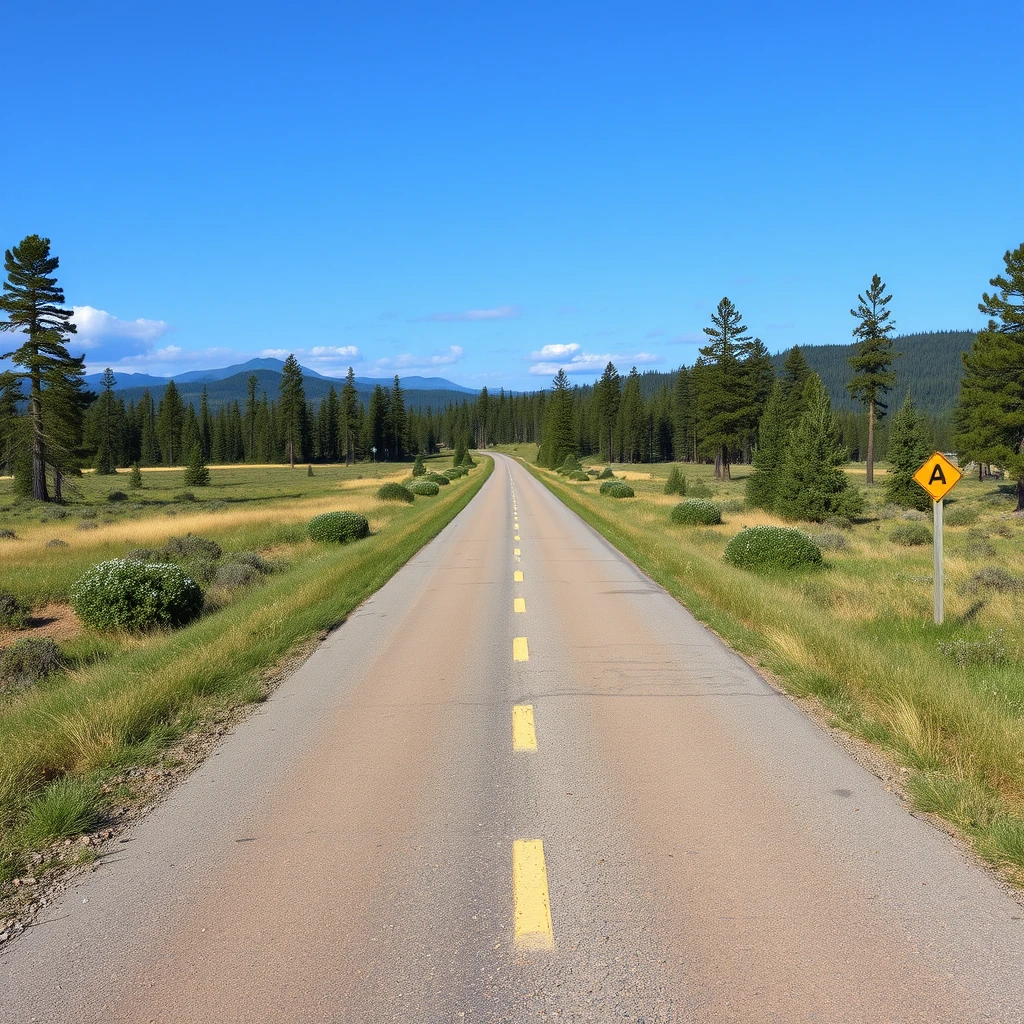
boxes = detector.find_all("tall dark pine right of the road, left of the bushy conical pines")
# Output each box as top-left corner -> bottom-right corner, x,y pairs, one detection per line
697,297 -> 752,480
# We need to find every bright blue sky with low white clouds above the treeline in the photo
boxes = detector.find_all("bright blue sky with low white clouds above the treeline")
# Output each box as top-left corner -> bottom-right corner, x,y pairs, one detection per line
0,0 -> 1024,389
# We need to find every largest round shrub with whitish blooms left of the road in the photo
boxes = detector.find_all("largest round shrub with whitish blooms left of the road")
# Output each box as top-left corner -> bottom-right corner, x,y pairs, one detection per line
71,558 -> 203,630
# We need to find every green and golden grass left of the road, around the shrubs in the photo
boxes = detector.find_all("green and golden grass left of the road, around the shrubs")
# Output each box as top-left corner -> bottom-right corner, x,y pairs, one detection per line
0,459 -> 494,896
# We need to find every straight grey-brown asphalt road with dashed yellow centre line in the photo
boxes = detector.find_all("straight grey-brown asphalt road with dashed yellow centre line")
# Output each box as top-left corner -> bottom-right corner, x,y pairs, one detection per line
0,457 -> 1024,1024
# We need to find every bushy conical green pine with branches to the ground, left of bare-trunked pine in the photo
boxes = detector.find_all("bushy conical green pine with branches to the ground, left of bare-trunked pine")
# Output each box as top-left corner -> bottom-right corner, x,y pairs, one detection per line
766,374 -> 863,522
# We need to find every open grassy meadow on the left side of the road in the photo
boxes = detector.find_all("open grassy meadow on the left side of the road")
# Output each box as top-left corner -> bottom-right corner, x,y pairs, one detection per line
0,457 -> 493,888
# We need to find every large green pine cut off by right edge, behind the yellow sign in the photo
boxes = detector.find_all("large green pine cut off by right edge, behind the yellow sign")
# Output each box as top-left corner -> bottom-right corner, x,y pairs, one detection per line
953,245 -> 1024,511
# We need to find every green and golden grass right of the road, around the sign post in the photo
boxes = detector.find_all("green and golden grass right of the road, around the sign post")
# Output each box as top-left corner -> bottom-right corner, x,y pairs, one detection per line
501,445 -> 1024,885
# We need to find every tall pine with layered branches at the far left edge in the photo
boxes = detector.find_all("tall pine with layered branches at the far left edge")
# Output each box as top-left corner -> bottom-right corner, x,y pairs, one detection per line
0,234 -> 84,502
